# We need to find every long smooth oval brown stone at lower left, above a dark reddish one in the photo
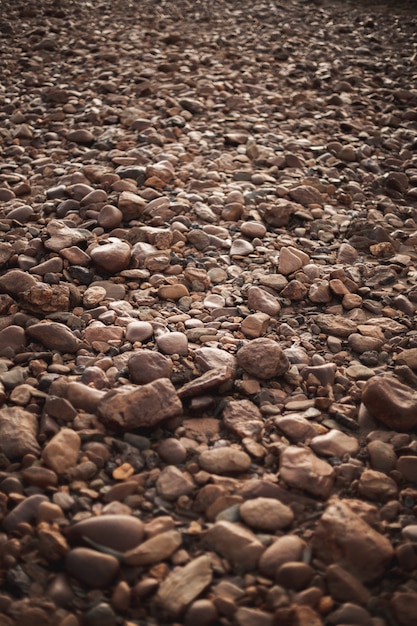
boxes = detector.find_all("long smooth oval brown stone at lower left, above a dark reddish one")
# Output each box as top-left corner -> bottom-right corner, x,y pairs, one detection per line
67,515 -> 144,552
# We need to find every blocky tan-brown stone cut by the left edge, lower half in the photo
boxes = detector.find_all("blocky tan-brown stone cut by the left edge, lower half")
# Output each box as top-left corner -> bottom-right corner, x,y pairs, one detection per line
0,407 -> 40,460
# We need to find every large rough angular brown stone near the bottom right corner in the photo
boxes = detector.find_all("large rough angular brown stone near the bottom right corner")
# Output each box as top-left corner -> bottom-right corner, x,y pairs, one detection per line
313,497 -> 394,583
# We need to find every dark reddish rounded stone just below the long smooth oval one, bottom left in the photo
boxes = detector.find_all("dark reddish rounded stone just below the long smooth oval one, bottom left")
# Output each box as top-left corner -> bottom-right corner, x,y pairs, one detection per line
65,548 -> 119,589
